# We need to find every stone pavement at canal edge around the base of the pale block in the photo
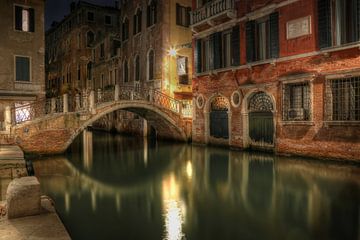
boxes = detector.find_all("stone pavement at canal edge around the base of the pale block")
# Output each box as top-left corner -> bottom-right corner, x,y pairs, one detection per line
0,197 -> 71,240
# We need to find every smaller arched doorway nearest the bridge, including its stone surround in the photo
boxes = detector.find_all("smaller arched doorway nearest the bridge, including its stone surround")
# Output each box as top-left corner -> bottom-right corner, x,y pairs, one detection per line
204,94 -> 231,143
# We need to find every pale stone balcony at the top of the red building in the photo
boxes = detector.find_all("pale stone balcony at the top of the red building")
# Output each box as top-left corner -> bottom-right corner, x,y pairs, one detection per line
191,0 -> 236,32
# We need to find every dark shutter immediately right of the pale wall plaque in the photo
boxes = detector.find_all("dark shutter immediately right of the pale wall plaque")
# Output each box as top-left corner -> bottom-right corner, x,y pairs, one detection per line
318,0 -> 332,48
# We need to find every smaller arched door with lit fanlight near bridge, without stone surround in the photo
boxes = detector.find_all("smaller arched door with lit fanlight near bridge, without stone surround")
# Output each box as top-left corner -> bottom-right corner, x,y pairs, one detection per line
210,96 -> 229,139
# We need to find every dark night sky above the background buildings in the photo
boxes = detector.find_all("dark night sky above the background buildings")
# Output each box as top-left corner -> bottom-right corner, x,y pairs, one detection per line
45,0 -> 115,29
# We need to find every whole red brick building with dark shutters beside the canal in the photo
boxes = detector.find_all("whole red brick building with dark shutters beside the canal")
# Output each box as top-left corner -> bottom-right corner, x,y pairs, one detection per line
191,0 -> 360,160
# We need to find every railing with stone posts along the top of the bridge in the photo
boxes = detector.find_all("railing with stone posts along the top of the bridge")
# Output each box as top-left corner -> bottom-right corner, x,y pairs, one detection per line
11,86 -> 192,125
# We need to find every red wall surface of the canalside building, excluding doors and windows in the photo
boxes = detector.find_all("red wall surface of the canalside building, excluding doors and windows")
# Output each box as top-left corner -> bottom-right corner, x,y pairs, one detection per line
193,0 -> 360,161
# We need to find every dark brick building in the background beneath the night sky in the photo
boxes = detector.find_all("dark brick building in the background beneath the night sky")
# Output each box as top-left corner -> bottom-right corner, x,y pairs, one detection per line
46,1 -> 120,96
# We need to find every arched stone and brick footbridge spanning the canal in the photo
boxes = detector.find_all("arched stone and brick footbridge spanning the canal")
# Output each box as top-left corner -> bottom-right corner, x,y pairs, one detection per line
5,86 -> 192,154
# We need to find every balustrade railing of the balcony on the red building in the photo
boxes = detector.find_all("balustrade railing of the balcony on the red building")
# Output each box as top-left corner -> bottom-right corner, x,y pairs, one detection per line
191,0 -> 235,25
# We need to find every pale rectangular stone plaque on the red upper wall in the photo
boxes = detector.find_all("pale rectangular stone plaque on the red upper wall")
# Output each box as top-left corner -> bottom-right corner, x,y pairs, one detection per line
286,16 -> 311,39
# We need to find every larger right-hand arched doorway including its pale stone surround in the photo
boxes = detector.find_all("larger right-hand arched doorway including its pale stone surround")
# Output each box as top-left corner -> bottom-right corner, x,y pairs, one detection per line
243,90 -> 276,149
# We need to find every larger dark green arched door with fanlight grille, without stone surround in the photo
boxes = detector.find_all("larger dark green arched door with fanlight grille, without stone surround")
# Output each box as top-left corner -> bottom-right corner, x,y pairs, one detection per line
248,92 -> 274,146
